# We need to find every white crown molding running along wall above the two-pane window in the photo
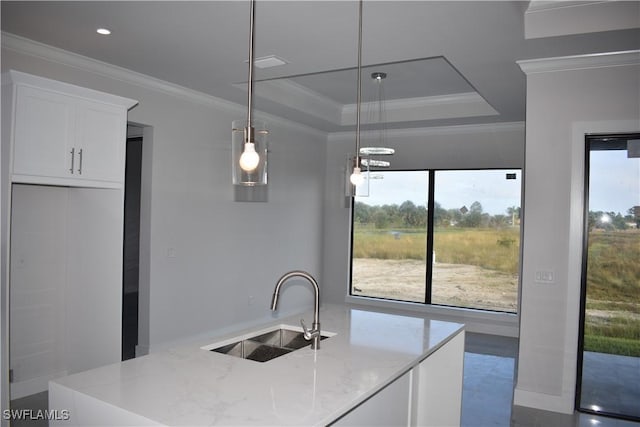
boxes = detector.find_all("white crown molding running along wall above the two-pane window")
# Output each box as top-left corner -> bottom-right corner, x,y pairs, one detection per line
327,122 -> 525,142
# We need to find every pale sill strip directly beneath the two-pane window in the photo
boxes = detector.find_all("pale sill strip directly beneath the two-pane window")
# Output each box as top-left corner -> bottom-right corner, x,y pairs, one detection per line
345,295 -> 519,337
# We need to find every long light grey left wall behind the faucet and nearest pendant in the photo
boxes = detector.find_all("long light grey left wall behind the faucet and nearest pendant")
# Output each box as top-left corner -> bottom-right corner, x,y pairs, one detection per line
2,34 -> 326,362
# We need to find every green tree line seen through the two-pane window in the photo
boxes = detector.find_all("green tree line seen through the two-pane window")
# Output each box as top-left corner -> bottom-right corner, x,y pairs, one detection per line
354,200 -> 520,229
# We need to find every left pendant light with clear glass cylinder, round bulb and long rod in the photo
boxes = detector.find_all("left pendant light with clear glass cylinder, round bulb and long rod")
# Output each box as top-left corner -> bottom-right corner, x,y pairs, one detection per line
231,0 -> 269,186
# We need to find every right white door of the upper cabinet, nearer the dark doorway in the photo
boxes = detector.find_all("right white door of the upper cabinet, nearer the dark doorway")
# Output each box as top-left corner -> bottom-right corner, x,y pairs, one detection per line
75,101 -> 127,182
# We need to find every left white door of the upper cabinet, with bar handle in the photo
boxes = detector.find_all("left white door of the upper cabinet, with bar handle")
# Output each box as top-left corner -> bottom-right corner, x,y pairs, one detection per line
13,86 -> 75,177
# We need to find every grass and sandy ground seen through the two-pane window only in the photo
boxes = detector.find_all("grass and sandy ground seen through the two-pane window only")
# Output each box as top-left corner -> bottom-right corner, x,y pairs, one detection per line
353,227 -> 520,312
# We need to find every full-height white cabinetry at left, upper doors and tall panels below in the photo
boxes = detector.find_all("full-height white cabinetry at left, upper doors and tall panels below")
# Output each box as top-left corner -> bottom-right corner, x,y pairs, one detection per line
0,71 -> 136,399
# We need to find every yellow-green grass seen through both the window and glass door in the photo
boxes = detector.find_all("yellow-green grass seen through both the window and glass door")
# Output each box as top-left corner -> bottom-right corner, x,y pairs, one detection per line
353,226 -> 640,357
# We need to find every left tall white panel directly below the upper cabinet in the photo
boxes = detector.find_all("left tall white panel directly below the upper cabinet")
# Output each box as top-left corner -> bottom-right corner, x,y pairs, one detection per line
9,184 -> 68,399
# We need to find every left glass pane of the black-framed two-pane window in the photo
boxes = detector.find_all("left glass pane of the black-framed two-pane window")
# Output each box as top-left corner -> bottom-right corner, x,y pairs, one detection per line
351,171 -> 429,302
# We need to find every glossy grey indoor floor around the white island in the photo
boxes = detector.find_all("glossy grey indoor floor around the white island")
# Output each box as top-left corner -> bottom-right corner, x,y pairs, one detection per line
11,333 -> 640,427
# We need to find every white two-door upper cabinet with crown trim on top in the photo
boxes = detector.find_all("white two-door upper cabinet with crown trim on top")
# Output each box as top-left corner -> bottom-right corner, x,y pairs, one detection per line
9,71 -> 136,187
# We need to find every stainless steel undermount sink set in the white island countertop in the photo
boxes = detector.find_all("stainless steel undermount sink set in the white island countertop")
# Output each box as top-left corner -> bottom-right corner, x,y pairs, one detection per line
203,326 -> 334,362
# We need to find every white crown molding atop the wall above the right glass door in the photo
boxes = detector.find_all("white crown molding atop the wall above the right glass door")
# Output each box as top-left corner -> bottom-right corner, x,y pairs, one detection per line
516,50 -> 640,75
